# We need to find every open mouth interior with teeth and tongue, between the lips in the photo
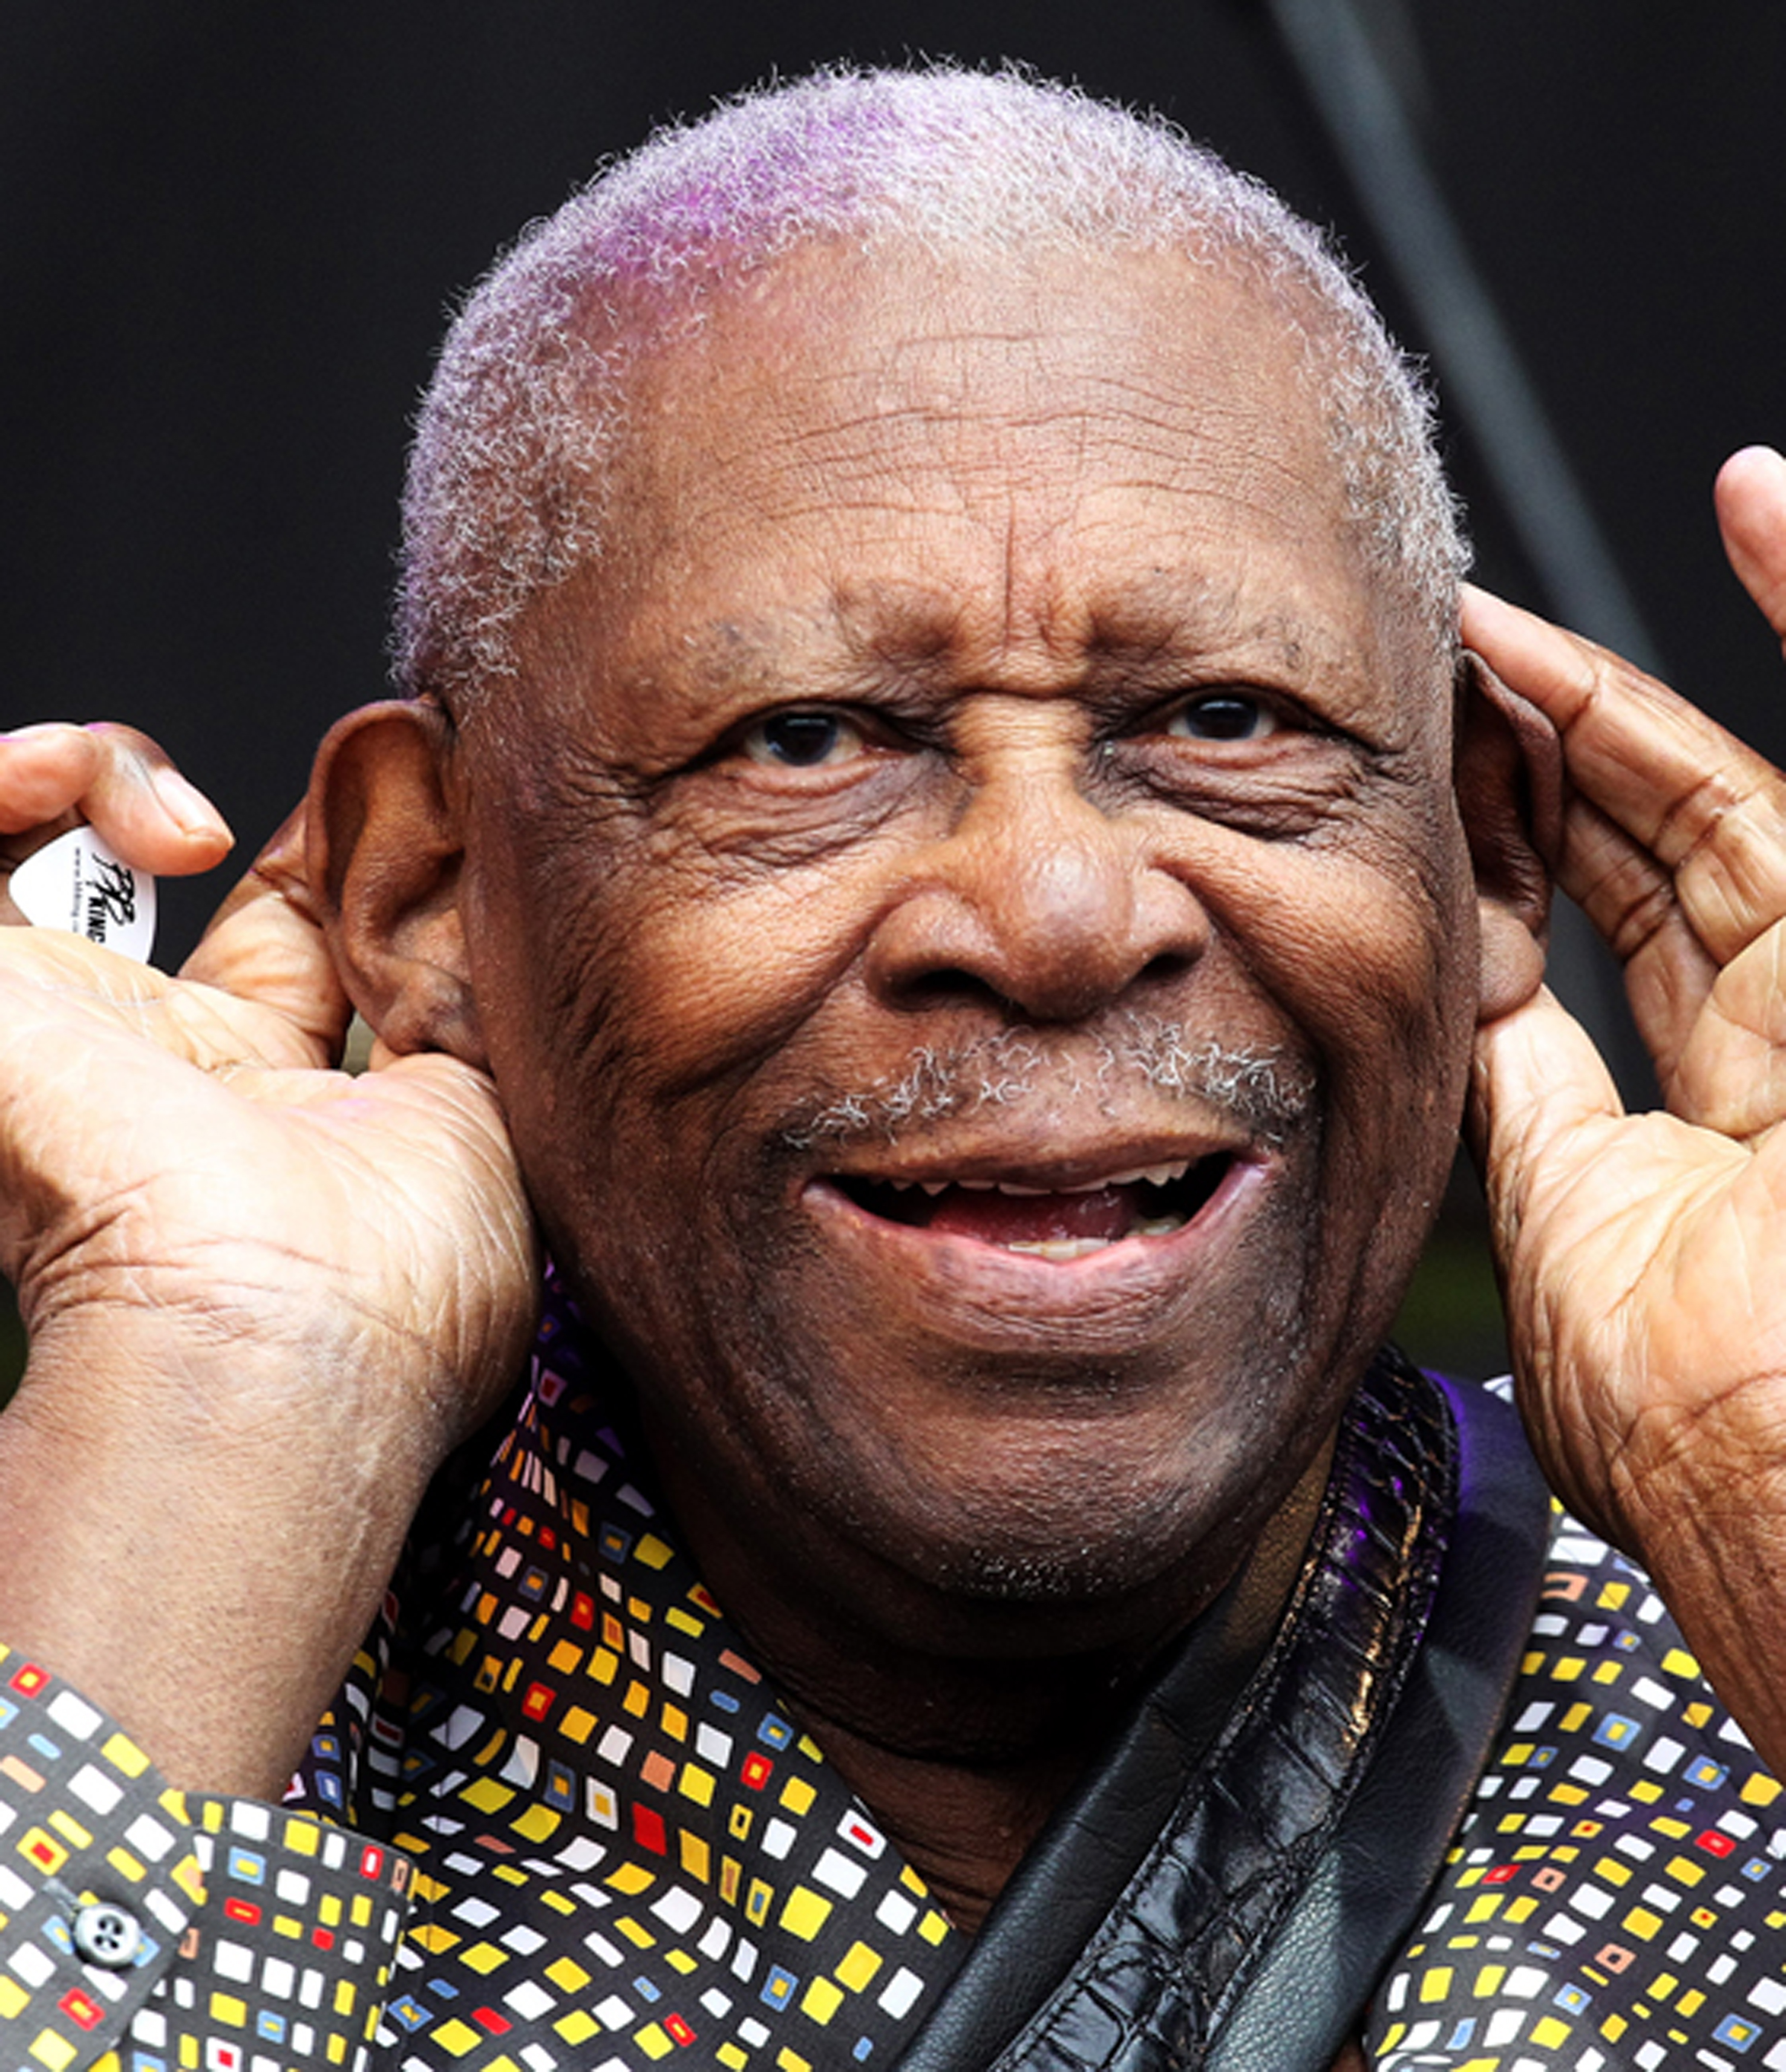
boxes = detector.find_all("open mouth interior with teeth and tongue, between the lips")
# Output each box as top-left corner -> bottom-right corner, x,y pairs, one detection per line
831,1154 -> 1235,1260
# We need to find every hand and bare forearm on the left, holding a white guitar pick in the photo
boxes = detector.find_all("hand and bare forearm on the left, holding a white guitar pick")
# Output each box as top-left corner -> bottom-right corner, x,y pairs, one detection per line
0,727 -> 537,1796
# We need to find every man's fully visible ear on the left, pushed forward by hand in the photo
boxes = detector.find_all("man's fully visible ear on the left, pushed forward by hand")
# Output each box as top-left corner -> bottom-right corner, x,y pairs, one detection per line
307,698 -> 487,1065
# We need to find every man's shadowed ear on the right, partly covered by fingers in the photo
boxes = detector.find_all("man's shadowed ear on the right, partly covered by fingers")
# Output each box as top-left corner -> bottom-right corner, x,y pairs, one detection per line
1454,649 -> 1565,1022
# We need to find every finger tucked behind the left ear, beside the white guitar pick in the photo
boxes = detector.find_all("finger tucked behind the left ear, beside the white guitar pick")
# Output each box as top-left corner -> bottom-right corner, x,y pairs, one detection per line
180,806 -> 352,1065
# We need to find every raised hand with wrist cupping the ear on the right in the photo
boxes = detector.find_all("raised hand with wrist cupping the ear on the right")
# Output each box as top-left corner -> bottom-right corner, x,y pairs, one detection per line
1463,448 -> 1786,1771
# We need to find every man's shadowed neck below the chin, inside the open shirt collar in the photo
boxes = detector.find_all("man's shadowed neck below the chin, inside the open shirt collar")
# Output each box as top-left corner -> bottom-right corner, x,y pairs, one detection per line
659,1442 -> 1332,1933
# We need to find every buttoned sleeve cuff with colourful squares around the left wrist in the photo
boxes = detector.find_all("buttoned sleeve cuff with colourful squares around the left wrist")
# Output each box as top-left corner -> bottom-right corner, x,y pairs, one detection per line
0,1647 -> 410,2072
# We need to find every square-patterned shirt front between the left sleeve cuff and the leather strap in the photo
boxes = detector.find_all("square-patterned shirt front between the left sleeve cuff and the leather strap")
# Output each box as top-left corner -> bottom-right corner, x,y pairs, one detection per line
281,1260 -> 960,2072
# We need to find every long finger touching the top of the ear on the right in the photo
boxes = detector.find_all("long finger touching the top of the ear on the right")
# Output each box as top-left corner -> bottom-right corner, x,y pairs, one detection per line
1463,586 -> 1786,964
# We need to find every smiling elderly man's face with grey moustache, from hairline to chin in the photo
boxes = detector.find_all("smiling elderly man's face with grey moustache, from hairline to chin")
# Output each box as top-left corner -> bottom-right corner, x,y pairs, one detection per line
451,253 -> 1475,1630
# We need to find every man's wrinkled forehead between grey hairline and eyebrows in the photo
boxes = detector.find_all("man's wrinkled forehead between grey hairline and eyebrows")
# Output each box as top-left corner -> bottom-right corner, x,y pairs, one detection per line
609,247 -> 1349,553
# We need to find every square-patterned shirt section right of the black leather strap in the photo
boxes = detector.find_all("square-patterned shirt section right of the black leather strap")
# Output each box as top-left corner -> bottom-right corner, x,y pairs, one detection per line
1367,1519 -> 1786,2072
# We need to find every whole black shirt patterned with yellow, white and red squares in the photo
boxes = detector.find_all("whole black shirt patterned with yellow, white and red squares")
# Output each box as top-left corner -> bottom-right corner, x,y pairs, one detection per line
0,1289 -> 1786,2072
